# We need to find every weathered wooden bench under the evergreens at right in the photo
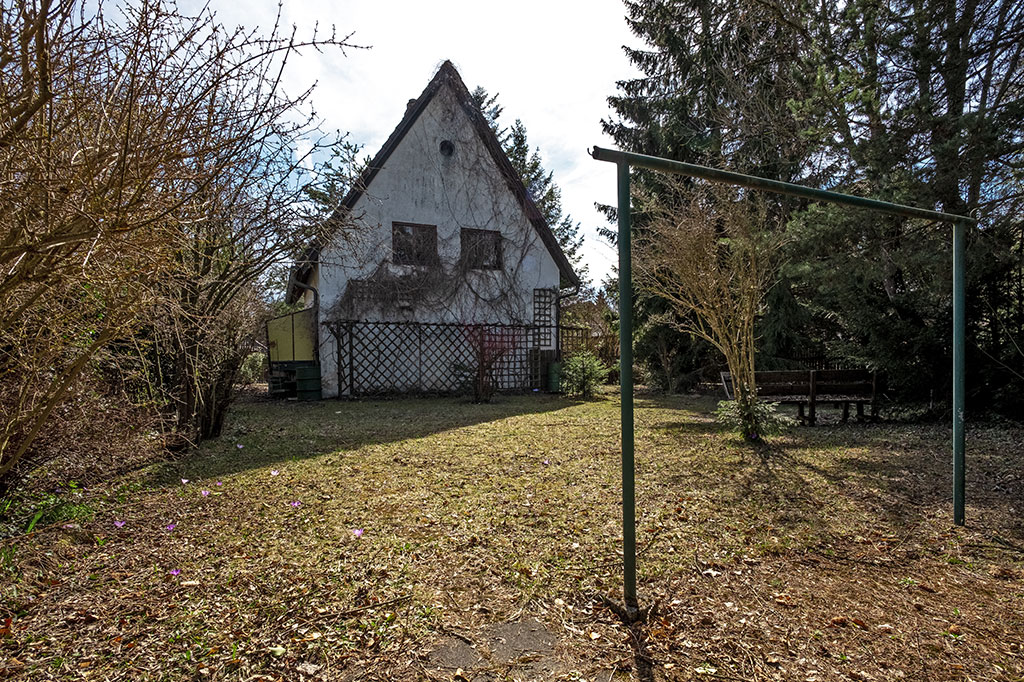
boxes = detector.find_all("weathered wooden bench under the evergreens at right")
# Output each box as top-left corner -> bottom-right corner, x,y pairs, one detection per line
722,370 -> 879,426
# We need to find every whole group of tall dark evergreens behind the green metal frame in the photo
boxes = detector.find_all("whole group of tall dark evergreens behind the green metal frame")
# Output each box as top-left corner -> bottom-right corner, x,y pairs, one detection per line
604,0 -> 1024,411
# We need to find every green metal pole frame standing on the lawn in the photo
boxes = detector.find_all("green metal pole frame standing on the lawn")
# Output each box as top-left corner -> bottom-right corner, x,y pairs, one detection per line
591,146 -> 978,620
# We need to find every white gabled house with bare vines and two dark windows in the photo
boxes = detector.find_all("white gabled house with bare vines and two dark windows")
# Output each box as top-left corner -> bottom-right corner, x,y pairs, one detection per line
270,61 -> 580,397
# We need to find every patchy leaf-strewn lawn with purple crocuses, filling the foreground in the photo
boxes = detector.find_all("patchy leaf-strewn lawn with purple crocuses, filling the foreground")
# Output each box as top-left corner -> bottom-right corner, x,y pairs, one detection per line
0,395 -> 1024,682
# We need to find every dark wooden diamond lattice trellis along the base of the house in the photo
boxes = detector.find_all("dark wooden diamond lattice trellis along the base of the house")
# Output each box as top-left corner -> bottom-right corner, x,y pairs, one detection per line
325,321 -> 587,397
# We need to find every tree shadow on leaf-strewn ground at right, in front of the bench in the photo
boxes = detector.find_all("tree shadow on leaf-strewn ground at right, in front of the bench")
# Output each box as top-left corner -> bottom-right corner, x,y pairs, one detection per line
651,406 -> 1024,542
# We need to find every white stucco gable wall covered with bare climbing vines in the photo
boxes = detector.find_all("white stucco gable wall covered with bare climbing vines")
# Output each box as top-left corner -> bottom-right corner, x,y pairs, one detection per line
315,85 -> 559,397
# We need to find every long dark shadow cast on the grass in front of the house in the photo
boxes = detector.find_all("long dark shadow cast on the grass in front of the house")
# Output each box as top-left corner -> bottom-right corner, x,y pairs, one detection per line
148,394 -> 578,486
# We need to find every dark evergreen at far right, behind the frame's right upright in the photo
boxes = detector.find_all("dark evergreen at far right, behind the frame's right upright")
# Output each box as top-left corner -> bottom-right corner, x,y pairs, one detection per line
792,0 -> 1024,403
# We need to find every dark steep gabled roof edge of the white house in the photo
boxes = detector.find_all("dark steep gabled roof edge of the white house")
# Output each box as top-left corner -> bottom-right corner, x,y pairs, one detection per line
287,60 -> 580,302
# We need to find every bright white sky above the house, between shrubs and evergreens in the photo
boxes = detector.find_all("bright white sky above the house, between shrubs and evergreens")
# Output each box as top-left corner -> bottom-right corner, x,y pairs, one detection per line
179,0 -> 638,284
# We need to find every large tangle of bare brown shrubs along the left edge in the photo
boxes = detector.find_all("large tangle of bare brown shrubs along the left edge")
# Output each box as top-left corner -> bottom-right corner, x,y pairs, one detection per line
0,0 -> 358,477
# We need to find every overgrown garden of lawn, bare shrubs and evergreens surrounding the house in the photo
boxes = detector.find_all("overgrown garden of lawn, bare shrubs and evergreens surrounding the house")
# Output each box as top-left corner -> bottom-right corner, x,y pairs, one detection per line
0,0 -> 1024,682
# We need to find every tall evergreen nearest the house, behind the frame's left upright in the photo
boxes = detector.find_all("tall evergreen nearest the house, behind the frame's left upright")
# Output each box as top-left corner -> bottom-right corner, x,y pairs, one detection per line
601,0 -> 807,388
